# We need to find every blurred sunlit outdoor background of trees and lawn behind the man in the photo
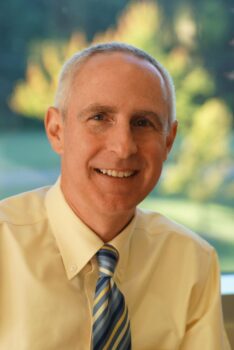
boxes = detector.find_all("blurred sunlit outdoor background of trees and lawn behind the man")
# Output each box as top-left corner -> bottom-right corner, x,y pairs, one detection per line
0,0 -> 234,272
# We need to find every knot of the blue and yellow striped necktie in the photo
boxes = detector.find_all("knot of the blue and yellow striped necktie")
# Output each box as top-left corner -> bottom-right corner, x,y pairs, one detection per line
97,244 -> 119,278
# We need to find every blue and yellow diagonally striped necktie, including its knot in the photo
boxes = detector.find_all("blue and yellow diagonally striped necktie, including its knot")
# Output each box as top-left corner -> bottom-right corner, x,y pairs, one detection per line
93,244 -> 131,350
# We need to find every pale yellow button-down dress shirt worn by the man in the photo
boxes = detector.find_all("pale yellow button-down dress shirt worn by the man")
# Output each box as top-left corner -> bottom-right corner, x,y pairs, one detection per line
0,182 -> 230,350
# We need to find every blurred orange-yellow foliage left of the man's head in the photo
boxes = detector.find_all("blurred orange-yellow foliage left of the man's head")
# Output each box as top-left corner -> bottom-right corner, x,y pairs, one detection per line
9,34 -> 87,119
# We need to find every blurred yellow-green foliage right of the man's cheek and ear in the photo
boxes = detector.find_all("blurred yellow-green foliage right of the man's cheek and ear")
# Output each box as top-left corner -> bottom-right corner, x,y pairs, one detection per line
164,99 -> 231,200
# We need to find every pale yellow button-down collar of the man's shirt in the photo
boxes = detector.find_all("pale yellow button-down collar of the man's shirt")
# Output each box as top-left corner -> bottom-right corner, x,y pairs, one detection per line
45,180 -> 136,279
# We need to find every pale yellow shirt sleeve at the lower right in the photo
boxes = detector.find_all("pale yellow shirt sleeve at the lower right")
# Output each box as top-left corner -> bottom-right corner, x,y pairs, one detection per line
180,251 -> 231,350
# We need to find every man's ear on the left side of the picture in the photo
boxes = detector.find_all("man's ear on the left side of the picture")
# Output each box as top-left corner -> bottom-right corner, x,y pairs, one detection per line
45,107 -> 64,155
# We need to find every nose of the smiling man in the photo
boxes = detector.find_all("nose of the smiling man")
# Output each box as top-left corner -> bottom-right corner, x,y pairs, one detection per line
108,124 -> 137,159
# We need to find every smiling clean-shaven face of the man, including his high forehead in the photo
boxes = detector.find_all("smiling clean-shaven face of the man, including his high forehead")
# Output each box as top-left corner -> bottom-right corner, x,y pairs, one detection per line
47,53 -> 176,217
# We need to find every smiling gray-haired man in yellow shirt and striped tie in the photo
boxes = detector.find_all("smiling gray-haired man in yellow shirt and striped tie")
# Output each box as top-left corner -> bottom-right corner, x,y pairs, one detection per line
0,43 -> 229,350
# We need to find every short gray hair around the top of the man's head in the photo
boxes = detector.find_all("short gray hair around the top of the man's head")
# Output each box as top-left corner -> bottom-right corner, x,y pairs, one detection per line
55,42 -> 176,125
